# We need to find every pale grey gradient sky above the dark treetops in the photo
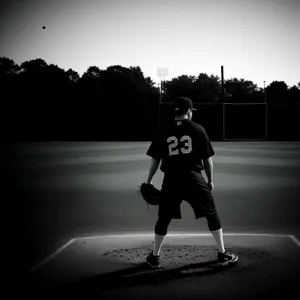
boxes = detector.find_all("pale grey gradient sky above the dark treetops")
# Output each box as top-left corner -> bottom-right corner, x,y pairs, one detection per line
0,0 -> 300,87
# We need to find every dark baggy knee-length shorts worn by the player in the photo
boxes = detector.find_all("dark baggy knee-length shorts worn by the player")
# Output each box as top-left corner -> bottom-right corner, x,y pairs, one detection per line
158,172 -> 217,219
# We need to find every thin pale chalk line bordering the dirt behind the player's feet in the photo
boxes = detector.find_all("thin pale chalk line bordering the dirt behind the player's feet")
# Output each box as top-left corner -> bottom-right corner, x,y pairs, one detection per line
29,232 -> 300,273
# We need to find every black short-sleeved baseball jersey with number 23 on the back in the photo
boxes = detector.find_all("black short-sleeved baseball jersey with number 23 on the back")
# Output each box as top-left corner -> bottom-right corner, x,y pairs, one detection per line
147,119 -> 215,174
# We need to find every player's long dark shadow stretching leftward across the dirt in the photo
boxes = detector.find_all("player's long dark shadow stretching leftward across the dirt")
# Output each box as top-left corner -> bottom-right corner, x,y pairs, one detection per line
66,260 -> 234,296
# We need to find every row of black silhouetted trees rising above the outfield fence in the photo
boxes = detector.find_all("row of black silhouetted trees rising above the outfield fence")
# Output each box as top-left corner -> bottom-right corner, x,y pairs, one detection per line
0,57 -> 300,108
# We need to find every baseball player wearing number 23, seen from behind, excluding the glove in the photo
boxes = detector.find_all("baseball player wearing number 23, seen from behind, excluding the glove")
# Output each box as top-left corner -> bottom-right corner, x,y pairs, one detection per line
146,97 -> 238,267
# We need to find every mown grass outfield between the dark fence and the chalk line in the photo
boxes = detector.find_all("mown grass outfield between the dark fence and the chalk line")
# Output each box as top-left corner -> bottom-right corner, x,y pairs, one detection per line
5,142 -> 300,270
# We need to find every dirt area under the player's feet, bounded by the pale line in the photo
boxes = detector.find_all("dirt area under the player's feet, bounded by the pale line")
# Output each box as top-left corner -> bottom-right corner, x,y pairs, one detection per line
30,234 -> 300,300
